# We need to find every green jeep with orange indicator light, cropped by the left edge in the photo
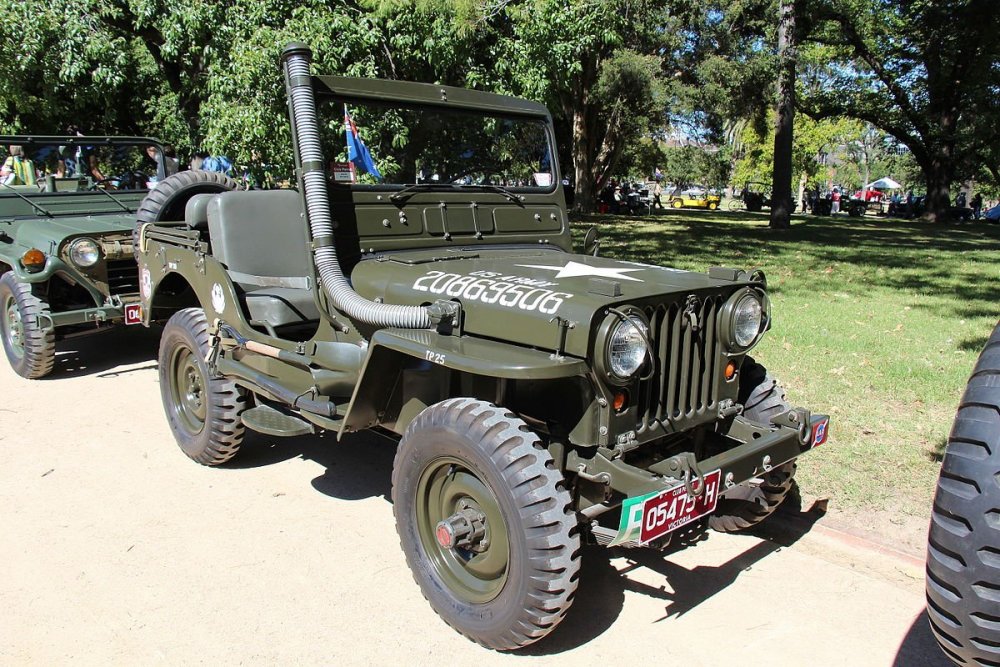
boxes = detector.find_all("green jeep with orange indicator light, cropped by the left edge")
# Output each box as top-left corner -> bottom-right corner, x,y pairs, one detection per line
0,136 -> 181,378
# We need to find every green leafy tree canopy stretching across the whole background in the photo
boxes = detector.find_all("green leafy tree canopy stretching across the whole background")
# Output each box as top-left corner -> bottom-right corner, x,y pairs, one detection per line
0,0 -> 1000,220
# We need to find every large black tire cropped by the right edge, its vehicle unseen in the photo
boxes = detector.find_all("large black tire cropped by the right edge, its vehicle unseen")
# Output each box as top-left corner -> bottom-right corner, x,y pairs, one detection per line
927,324 -> 1000,665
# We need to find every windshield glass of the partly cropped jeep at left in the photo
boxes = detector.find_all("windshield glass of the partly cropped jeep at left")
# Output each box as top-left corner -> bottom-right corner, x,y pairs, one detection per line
0,137 -> 164,192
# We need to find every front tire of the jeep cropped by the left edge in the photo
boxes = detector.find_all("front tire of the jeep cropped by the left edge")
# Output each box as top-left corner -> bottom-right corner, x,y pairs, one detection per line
0,271 -> 56,380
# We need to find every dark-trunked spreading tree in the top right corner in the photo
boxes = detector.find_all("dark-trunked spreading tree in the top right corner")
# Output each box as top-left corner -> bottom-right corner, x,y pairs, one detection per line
801,0 -> 1000,220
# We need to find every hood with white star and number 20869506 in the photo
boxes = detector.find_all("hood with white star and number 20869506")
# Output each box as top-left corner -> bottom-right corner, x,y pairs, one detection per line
351,247 -> 748,357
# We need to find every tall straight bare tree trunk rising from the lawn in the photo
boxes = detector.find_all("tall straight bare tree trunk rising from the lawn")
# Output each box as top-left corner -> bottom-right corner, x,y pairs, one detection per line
771,0 -> 797,229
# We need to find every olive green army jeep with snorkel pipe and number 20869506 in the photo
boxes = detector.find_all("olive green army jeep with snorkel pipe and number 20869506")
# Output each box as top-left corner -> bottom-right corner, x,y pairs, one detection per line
138,44 -> 827,650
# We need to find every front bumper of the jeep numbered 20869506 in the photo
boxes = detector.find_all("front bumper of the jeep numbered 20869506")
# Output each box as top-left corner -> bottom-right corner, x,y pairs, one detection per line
566,408 -> 829,544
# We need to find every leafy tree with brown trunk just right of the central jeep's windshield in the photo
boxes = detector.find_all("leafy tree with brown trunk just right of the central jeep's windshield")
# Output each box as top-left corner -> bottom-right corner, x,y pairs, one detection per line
498,0 -> 673,211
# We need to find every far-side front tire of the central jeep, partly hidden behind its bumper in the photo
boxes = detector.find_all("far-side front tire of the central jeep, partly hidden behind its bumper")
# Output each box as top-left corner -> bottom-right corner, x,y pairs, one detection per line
708,357 -> 796,533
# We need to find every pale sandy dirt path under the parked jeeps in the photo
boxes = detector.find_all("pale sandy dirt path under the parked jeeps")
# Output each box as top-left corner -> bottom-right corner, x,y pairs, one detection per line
0,330 -> 948,667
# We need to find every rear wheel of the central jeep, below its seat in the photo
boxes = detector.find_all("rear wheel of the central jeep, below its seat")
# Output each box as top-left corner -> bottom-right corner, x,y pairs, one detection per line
159,308 -> 246,466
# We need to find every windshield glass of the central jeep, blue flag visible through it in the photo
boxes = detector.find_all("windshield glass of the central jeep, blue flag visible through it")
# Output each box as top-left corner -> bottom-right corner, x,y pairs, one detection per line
321,102 -> 554,191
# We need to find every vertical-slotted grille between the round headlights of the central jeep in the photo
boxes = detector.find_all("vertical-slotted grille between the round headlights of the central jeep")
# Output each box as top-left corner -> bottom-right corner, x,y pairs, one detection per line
639,297 -> 723,432
